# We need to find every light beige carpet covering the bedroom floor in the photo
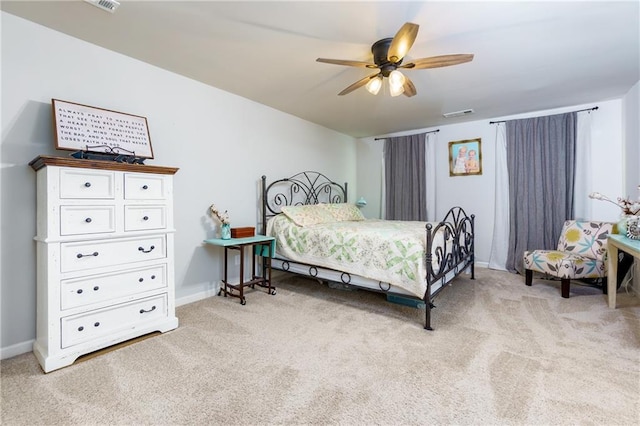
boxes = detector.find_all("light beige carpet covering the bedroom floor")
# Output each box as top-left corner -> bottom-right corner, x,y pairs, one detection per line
1,268 -> 640,425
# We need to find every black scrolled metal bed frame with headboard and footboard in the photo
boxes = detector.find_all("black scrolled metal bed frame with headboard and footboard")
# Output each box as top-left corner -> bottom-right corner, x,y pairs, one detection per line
261,171 -> 475,330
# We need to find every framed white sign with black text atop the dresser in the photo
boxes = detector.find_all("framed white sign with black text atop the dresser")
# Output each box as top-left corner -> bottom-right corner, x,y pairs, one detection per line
51,99 -> 153,158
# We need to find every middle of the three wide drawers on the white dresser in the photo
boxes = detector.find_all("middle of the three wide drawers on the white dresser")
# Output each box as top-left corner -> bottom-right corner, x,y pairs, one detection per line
60,264 -> 167,310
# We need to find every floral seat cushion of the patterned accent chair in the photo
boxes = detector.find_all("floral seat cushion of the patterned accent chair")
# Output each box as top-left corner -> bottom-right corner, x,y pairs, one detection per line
523,250 -> 606,278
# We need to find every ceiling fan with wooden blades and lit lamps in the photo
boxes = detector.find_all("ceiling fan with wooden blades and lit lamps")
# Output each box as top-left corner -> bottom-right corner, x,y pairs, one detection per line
316,22 -> 473,97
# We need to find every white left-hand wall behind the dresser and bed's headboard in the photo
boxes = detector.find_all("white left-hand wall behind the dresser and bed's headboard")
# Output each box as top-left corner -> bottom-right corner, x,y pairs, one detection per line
0,12 -> 356,358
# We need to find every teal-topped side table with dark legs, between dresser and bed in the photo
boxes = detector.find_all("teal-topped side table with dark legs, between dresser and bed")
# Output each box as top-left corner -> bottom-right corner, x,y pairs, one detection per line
204,235 -> 276,305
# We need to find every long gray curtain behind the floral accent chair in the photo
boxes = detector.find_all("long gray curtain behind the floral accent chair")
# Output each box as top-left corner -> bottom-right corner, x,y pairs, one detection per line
508,112 -> 577,273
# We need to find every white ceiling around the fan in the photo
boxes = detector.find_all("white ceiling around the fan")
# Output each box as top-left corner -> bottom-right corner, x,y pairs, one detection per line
0,0 -> 640,137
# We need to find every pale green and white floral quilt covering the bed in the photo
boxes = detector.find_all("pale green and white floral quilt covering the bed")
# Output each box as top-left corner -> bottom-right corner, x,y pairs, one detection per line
267,214 -> 442,297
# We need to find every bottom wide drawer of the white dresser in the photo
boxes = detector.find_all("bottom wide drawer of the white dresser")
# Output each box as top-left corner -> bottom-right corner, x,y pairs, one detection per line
61,294 -> 167,348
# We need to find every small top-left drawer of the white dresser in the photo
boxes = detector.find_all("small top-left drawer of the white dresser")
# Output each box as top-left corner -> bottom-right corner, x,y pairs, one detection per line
60,169 -> 116,200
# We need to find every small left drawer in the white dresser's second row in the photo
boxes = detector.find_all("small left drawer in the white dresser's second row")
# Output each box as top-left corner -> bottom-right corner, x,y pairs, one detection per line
60,206 -> 116,235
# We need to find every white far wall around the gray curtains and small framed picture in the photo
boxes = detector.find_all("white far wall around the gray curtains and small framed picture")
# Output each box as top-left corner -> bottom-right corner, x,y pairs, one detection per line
357,99 -> 624,264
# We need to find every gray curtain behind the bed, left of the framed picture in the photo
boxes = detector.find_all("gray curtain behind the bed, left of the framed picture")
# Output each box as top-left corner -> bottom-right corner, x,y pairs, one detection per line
384,133 -> 427,221
